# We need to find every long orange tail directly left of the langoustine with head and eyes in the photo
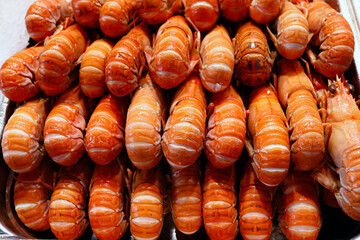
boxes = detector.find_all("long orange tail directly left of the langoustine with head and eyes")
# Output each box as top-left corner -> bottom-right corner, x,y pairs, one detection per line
277,59 -> 325,171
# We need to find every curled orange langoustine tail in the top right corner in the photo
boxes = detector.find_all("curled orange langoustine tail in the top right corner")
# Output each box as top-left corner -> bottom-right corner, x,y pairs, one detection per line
306,0 -> 355,78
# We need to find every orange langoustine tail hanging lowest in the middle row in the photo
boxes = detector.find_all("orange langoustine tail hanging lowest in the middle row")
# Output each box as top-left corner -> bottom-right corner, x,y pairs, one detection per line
246,84 -> 290,186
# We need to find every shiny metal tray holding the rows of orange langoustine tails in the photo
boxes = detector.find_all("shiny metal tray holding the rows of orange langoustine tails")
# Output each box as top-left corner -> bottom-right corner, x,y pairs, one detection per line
0,0 -> 360,240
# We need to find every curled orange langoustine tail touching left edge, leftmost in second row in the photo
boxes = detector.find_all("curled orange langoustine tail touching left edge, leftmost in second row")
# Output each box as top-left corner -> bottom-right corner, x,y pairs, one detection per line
0,46 -> 44,102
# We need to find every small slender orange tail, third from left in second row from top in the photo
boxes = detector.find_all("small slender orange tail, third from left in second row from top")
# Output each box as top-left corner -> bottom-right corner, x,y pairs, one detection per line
79,38 -> 113,98
